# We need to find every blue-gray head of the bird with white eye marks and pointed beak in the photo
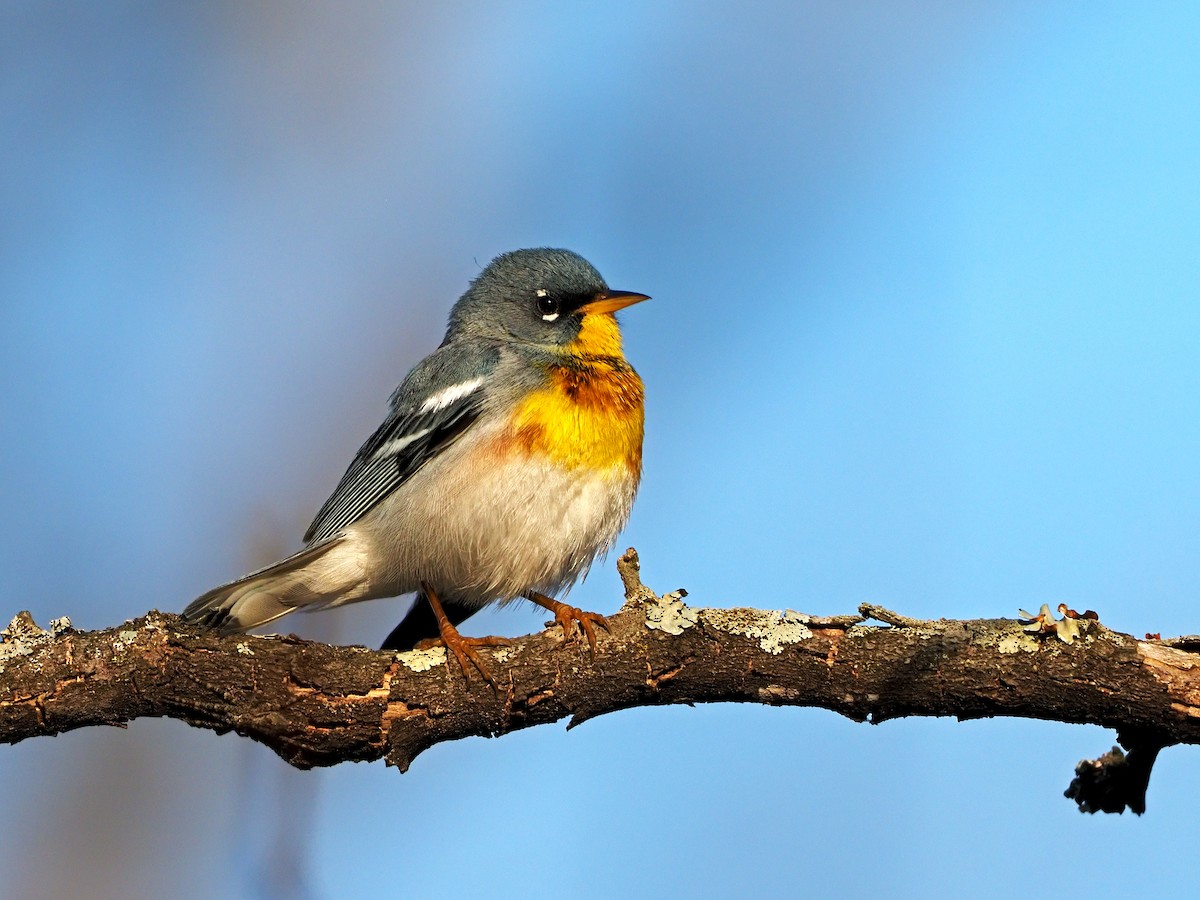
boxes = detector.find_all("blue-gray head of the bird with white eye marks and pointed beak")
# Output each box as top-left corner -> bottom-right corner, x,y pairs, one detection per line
446,247 -> 647,346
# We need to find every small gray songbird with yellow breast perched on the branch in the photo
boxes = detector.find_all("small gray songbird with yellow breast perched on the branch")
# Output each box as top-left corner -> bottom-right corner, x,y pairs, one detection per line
184,248 -> 649,682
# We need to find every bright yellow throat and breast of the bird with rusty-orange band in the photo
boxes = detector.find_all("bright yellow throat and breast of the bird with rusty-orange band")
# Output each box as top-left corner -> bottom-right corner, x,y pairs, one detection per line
499,314 -> 644,479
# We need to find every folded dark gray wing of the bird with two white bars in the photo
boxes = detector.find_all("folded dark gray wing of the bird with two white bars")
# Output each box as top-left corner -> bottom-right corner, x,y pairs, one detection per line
304,343 -> 499,544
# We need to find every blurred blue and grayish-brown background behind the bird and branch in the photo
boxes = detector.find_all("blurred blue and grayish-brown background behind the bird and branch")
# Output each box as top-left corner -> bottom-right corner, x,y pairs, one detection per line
0,0 -> 1200,898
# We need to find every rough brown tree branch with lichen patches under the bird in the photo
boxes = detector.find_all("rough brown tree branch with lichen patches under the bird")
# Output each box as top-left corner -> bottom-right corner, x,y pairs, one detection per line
0,551 -> 1200,812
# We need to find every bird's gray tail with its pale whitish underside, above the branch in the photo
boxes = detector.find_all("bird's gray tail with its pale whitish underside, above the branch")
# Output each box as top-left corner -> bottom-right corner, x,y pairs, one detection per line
184,538 -> 364,635
